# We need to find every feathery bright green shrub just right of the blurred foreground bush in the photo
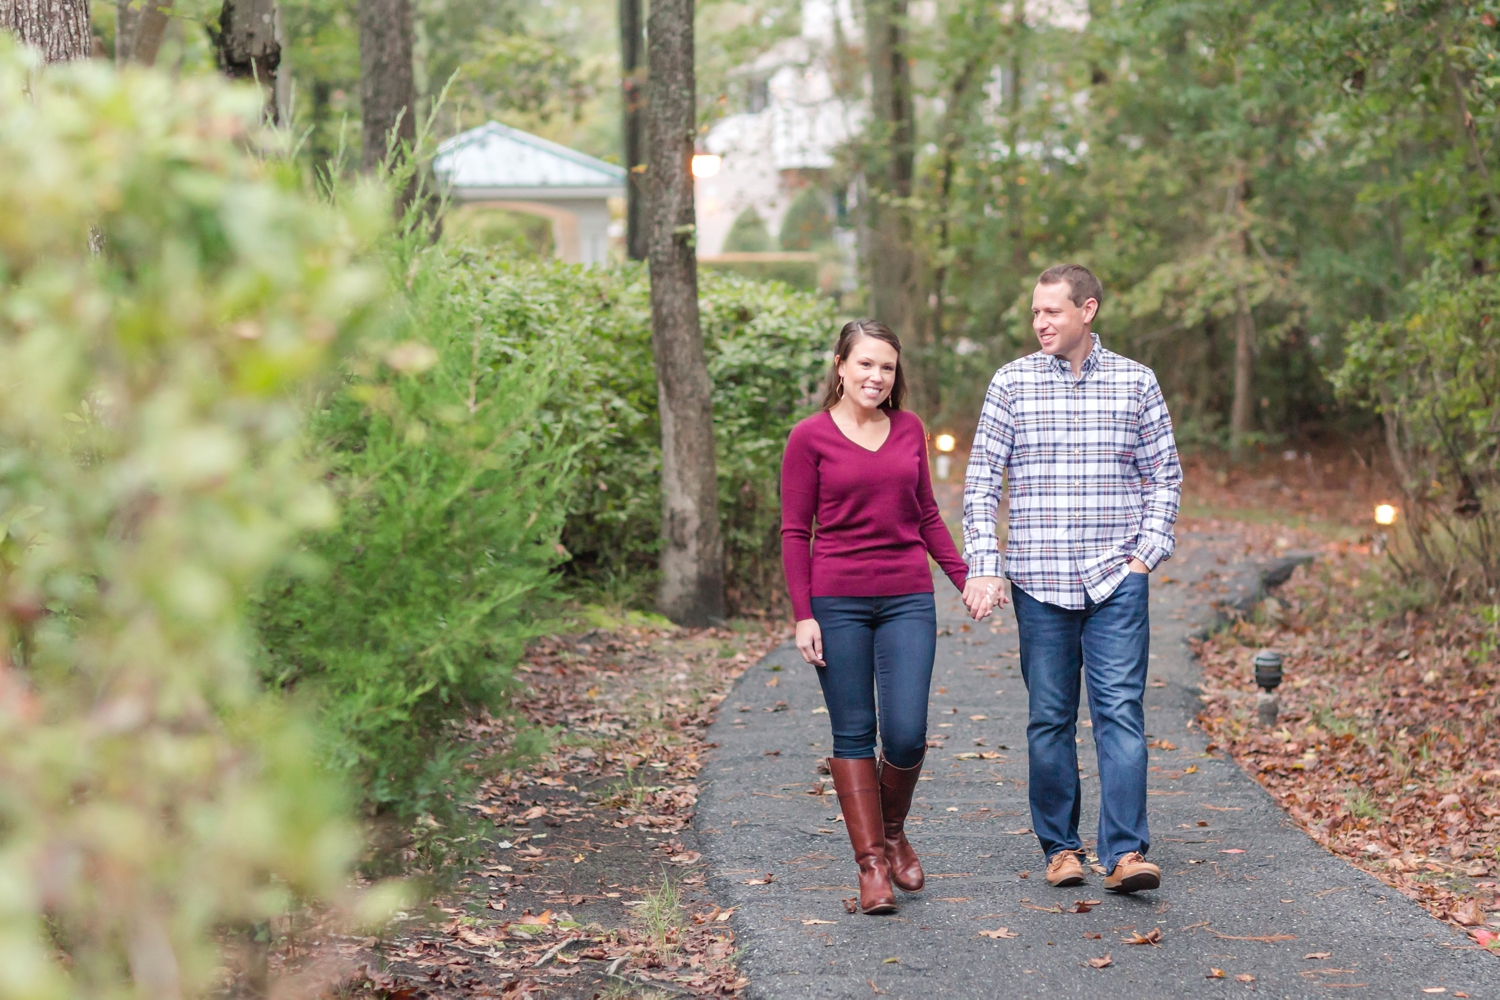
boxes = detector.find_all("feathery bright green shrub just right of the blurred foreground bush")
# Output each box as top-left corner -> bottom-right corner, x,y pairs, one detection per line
260,241 -> 579,849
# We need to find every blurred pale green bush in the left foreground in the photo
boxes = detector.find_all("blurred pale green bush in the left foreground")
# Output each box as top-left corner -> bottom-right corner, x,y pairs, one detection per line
0,48 -> 389,1000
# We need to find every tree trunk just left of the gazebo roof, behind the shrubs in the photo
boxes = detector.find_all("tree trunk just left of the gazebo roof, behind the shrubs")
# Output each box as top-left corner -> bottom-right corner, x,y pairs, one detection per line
360,0 -> 417,173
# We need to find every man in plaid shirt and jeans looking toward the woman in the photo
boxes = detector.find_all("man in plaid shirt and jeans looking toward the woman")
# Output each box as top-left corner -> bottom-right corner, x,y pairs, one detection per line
963,264 -> 1182,892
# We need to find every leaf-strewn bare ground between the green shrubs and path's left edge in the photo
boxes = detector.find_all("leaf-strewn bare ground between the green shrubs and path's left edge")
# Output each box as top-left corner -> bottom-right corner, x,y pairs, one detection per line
273,622 -> 782,1000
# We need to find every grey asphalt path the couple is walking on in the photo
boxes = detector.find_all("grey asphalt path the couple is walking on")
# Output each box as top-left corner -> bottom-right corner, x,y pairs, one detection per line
698,532 -> 1500,1000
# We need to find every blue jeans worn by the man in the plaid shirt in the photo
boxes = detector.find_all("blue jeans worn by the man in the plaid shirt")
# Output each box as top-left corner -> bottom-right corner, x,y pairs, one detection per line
1011,573 -> 1151,871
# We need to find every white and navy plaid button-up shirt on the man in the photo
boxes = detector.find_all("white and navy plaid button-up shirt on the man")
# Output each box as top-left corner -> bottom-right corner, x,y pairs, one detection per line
963,334 -> 1182,609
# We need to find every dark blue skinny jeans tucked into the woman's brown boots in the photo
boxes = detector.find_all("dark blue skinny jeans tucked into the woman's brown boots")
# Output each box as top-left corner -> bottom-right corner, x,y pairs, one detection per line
813,594 -> 938,768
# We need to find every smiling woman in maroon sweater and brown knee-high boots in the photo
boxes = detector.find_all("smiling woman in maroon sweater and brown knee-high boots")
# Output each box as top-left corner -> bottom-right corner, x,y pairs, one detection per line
782,319 -> 968,913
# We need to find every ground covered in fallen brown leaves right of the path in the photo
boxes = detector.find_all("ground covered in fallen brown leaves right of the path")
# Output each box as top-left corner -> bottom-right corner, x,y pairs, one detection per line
1197,523 -> 1500,940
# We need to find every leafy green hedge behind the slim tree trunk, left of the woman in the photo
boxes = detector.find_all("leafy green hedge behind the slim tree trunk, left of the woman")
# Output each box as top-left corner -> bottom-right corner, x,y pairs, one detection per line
325,250 -> 836,609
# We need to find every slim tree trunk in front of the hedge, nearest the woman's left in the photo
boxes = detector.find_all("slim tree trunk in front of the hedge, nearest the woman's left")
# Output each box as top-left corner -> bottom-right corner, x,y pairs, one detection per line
647,0 -> 725,627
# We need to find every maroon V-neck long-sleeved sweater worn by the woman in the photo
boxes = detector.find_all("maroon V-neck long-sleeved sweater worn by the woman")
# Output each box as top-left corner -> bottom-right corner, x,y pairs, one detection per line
782,411 -> 969,621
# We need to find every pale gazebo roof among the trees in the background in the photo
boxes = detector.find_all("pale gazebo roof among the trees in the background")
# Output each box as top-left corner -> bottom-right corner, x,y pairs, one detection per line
432,121 -> 626,201
